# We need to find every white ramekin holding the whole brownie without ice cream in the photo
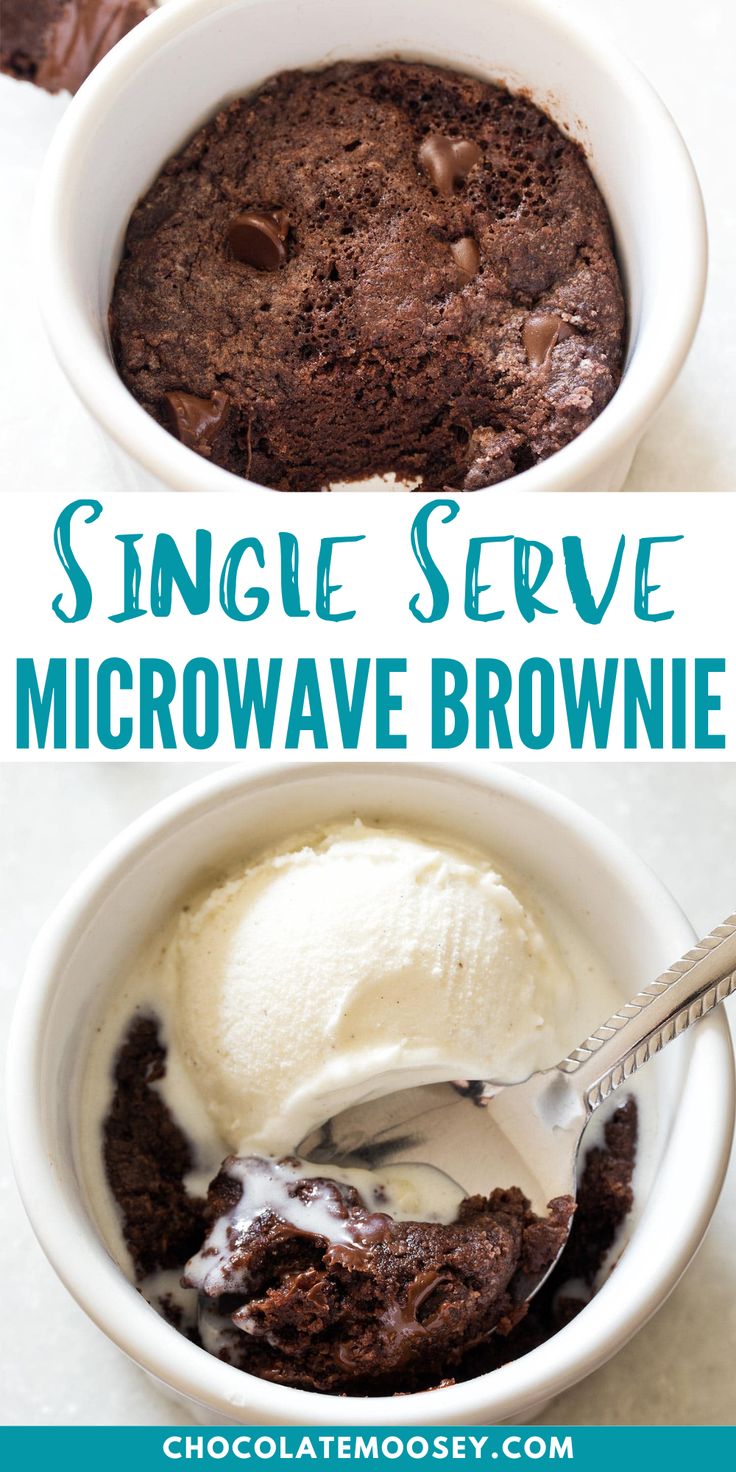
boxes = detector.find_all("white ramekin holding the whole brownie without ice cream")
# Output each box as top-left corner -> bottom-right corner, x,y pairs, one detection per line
35,0 -> 707,490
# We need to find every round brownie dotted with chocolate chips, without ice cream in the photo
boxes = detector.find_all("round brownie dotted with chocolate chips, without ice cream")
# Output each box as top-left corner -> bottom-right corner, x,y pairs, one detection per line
110,60 -> 624,490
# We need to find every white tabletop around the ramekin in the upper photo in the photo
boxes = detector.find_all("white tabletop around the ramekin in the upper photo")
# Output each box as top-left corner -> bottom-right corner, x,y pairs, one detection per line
0,0 -> 736,495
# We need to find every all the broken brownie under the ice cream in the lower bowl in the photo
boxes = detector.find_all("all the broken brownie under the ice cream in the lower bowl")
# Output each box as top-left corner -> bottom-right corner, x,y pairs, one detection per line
103,1017 -> 637,1394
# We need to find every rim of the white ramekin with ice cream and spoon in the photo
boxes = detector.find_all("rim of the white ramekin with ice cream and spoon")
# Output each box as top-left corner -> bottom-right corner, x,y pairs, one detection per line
7,762 -> 735,1425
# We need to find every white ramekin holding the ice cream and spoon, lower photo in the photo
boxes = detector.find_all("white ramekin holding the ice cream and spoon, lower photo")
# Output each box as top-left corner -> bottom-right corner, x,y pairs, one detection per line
7,762 -> 733,1425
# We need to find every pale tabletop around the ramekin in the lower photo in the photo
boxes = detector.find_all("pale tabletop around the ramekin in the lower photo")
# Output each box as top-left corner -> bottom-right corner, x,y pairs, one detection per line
0,764 -> 736,1425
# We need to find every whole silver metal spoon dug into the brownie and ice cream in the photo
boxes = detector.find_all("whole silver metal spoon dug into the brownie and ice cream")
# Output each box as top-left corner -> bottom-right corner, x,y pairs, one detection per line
299,914 -> 736,1292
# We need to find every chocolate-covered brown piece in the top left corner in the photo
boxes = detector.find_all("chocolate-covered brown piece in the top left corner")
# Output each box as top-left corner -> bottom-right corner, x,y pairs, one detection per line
0,0 -> 152,93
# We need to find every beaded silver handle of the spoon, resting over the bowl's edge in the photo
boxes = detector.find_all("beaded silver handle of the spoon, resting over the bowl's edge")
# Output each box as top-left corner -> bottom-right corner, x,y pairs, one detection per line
558,914 -> 736,1114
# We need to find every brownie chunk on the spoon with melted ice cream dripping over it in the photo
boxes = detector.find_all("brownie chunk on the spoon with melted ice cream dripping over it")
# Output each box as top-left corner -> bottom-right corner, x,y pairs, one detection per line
183,1158 -> 574,1394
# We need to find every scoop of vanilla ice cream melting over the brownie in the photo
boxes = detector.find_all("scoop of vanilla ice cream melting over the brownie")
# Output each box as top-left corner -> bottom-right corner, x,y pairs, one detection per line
168,823 -> 576,1154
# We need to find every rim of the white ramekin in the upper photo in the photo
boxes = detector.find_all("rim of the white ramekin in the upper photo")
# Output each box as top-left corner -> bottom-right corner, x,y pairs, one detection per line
34,0 -> 708,495
